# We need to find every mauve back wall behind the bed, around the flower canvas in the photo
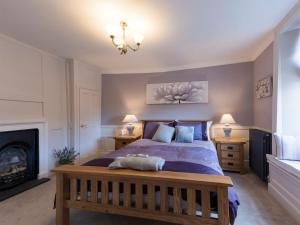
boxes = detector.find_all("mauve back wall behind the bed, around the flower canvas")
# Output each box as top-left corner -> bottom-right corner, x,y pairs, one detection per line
101,62 -> 253,125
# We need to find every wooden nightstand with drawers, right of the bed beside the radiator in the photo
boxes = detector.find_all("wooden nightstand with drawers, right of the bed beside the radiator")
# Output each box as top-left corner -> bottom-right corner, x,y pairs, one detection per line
214,138 -> 247,173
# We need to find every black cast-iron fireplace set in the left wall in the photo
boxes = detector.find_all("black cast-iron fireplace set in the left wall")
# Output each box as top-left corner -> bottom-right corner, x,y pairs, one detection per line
0,129 -> 48,201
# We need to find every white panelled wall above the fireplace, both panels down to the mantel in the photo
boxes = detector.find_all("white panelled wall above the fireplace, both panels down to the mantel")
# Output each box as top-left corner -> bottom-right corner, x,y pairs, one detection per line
0,36 -> 43,121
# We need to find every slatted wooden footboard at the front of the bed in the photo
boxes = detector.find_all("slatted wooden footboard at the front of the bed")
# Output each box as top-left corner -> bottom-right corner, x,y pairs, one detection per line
53,120 -> 233,225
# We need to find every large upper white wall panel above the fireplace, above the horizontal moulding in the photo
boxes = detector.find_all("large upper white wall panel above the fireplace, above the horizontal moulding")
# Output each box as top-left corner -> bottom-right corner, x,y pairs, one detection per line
0,35 -> 43,103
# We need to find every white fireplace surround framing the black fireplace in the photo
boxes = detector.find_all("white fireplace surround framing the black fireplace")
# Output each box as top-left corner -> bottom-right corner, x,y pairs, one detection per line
0,119 -> 49,178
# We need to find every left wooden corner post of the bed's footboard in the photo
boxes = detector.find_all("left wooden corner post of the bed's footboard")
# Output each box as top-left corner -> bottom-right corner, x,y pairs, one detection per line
56,173 -> 70,225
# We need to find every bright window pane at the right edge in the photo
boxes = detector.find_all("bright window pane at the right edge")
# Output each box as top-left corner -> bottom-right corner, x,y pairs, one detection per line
277,29 -> 300,135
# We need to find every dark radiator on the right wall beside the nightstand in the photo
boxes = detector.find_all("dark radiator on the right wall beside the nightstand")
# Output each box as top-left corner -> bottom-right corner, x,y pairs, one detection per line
249,129 -> 272,182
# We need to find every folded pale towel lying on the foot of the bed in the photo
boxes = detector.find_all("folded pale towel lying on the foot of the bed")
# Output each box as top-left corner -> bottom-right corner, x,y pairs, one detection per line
108,154 -> 165,171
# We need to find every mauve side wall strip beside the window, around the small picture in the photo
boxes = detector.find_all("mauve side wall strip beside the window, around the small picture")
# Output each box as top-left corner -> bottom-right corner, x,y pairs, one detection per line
253,44 -> 273,130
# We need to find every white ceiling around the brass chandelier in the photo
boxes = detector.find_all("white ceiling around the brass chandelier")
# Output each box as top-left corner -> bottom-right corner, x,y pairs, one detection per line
0,0 -> 298,73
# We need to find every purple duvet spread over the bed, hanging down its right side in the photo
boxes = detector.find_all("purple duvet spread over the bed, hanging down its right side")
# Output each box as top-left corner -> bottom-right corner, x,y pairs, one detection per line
84,139 -> 240,224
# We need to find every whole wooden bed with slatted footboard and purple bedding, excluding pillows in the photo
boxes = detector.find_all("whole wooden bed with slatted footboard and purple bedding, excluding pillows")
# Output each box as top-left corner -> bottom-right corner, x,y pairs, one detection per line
54,121 -> 239,225
